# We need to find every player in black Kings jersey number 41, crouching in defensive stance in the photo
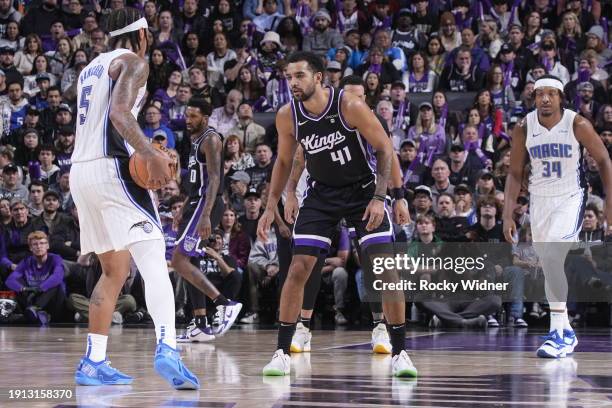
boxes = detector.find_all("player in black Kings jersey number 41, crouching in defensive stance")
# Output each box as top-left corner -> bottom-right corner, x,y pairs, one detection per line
257,52 -> 416,376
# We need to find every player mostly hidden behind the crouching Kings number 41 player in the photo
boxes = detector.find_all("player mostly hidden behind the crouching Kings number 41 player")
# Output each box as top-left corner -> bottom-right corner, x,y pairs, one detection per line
284,75 -> 410,354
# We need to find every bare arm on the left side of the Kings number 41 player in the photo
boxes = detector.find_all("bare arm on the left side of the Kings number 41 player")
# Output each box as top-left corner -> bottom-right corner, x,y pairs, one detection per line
257,104 -> 296,242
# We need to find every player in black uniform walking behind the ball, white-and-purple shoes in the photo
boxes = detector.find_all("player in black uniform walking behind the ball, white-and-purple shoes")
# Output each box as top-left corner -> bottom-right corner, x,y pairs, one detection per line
172,98 -> 242,342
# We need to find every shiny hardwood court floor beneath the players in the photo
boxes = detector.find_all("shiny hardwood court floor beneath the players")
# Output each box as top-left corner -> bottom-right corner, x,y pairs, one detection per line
0,327 -> 612,408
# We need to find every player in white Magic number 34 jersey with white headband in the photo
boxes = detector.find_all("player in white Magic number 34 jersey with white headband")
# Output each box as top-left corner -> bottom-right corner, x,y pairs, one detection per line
503,75 -> 612,358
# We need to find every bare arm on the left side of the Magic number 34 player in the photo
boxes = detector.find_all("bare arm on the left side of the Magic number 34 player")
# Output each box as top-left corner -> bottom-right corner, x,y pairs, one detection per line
503,118 -> 527,242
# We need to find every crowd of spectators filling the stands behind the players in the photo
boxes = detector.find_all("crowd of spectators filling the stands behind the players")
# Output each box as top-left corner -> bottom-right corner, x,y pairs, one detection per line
0,0 -> 612,327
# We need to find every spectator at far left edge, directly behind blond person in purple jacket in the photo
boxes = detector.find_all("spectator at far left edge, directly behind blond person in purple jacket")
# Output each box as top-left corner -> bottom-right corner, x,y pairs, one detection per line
0,198 -> 36,273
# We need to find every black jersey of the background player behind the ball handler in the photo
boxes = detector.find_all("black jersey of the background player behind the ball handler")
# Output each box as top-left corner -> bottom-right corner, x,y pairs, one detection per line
187,127 -> 223,200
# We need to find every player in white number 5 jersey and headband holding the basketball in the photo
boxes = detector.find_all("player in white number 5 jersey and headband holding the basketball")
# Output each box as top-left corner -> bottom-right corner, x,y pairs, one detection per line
70,8 -> 200,389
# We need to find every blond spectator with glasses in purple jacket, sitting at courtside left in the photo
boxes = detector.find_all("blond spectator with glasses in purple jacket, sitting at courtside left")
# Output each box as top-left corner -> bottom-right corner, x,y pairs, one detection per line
6,231 -> 66,325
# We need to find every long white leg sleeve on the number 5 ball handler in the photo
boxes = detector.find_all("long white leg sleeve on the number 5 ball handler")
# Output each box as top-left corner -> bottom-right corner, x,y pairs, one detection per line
129,239 -> 176,349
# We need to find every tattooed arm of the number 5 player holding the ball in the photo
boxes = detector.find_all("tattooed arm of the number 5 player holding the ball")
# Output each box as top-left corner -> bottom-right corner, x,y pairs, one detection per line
109,57 -> 151,153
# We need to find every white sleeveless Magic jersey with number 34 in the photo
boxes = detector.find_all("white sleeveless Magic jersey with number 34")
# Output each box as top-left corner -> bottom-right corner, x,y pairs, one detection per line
525,109 -> 586,196
